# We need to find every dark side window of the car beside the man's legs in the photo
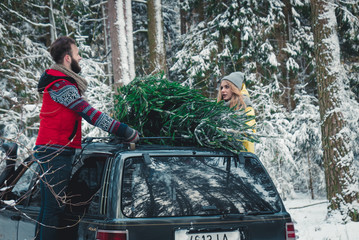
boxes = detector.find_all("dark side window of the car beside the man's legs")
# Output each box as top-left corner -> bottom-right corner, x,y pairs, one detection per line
66,156 -> 107,213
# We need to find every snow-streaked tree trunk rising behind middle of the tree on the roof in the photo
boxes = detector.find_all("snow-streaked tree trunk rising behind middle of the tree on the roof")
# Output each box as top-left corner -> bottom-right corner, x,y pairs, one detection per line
147,0 -> 167,73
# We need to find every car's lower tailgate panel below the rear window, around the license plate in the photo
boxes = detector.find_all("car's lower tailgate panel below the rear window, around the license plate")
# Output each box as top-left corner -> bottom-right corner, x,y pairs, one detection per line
93,215 -> 290,240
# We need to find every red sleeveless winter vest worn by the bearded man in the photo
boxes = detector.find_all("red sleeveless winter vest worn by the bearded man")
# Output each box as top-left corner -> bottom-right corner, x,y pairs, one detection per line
36,69 -> 82,148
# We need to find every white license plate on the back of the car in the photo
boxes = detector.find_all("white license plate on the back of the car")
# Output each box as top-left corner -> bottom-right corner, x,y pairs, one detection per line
175,230 -> 241,240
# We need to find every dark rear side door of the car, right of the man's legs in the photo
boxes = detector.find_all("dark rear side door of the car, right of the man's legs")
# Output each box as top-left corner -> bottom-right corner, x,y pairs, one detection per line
63,154 -> 108,240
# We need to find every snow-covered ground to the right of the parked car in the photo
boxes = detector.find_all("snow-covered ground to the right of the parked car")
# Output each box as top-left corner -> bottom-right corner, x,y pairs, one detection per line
284,195 -> 359,240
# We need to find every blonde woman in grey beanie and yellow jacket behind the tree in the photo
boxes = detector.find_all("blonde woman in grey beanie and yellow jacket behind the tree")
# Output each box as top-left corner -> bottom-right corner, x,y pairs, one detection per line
217,72 -> 256,153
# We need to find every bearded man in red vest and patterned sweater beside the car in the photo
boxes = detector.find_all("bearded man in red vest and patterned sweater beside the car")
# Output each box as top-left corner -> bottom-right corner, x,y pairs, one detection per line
35,37 -> 139,240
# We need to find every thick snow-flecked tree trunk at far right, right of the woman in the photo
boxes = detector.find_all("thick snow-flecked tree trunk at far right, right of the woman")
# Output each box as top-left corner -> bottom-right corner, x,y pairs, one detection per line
311,0 -> 358,220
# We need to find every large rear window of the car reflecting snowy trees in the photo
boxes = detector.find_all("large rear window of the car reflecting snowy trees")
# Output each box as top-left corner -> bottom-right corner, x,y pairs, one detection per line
121,156 -> 281,218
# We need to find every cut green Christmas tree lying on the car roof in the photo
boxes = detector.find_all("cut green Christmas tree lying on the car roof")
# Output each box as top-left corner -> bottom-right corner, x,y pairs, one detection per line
115,74 -> 257,153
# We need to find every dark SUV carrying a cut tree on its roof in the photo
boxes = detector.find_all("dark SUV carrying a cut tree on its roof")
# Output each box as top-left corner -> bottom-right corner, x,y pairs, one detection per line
0,139 -> 295,240
